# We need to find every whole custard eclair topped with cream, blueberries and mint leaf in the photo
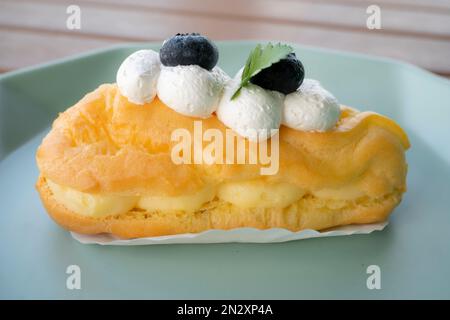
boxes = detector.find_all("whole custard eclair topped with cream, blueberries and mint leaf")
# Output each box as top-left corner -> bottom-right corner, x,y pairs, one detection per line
36,34 -> 409,238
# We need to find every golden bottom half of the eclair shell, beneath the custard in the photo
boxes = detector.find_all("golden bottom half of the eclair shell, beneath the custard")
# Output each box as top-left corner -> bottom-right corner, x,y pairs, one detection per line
36,176 -> 402,239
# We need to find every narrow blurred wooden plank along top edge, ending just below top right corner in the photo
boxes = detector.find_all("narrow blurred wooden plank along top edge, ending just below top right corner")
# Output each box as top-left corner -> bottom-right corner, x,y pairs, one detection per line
37,0 -> 450,37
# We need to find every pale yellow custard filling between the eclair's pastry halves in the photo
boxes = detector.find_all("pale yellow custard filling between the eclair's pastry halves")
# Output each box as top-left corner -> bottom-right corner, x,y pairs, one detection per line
47,179 -> 364,217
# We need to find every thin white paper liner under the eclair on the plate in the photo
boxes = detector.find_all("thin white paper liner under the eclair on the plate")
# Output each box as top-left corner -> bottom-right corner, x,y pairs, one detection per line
71,221 -> 388,246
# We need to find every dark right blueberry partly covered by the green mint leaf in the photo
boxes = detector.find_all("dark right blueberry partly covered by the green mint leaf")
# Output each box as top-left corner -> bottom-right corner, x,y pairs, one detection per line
250,53 -> 305,94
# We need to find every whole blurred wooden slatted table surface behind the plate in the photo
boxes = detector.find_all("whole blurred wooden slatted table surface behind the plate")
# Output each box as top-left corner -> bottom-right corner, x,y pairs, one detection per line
0,0 -> 450,78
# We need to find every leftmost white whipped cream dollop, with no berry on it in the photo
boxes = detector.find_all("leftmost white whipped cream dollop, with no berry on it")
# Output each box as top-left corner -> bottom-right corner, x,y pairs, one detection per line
116,50 -> 161,104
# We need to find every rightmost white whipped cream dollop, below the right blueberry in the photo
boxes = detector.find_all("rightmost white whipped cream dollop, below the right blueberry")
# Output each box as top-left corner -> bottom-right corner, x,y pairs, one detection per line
282,79 -> 341,131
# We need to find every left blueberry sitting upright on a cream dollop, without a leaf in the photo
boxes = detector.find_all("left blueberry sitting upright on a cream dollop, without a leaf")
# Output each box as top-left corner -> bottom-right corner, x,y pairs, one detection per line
159,33 -> 219,70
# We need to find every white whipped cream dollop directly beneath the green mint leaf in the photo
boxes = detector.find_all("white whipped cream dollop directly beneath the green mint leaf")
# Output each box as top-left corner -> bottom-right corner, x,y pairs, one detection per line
216,77 -> 284,141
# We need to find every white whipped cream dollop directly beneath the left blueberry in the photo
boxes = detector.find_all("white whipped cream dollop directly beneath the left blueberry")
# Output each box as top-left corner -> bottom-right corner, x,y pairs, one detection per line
157,65 -> 230,118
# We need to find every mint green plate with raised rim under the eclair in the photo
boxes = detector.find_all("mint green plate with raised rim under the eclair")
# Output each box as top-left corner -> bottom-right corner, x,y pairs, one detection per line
0,42 -> 450,299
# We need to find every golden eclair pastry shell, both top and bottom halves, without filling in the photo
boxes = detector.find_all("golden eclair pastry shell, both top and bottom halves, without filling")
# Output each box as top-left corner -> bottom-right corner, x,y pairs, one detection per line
36,84 -> 409,238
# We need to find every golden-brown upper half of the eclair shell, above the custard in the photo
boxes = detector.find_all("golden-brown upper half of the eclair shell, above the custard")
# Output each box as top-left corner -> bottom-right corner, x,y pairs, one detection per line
36,84 -> 409,196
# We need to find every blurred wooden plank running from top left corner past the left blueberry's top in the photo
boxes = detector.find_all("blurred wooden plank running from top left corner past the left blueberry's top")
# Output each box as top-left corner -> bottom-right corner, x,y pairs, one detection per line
0,1 -> 450,73
